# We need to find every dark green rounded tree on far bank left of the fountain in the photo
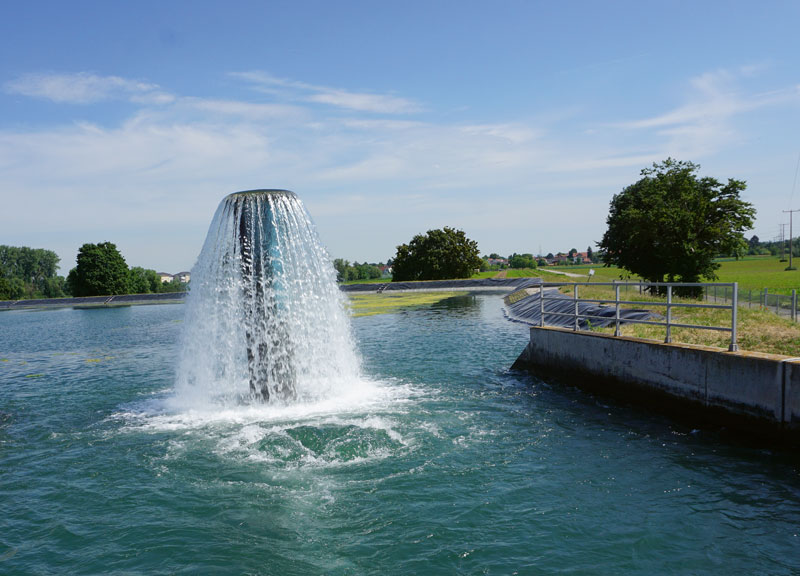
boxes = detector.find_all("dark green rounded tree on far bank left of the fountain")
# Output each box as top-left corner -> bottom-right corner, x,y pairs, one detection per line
67,242 -> 130,296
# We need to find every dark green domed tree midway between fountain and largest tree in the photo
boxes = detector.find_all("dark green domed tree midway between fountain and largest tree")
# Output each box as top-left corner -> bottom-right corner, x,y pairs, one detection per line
392,226 -> 481,282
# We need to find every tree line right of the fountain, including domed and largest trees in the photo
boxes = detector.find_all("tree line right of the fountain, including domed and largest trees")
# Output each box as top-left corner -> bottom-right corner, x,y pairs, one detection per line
386,158 -> 756,294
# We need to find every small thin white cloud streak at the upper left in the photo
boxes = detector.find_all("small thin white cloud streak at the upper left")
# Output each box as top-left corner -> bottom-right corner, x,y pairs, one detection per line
4,72 -> 174,104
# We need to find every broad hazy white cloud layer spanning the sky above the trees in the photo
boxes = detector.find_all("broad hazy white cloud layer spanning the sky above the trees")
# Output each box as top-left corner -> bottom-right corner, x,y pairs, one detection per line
0,67 -> 800,269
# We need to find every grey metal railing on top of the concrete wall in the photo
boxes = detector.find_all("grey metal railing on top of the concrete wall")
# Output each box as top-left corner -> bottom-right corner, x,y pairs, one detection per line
534,282 -> 739,352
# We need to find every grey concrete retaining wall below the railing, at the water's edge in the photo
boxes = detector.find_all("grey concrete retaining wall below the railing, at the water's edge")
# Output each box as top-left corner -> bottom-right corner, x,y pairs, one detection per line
514,328 -> 800,441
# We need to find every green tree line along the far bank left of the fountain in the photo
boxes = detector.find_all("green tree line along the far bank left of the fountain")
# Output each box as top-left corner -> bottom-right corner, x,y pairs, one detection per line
0,242 -> 187,300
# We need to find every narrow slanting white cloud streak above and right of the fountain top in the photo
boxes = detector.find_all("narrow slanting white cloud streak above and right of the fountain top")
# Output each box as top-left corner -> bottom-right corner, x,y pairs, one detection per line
232,71 -> 423,114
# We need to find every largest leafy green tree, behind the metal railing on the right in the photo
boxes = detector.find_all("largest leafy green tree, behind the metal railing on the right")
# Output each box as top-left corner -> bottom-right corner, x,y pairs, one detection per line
598,158 -> 755,282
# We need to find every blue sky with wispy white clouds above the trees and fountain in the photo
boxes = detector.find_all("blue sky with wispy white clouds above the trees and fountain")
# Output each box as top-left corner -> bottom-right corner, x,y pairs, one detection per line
0,0 -> 800,274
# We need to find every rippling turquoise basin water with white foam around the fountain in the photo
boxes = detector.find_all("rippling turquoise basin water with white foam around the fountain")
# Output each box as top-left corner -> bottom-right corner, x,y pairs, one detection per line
0,295 -> 800,575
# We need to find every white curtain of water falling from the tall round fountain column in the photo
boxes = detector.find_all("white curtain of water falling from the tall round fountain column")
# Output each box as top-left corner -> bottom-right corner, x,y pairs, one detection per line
177,190 -> 358,403
